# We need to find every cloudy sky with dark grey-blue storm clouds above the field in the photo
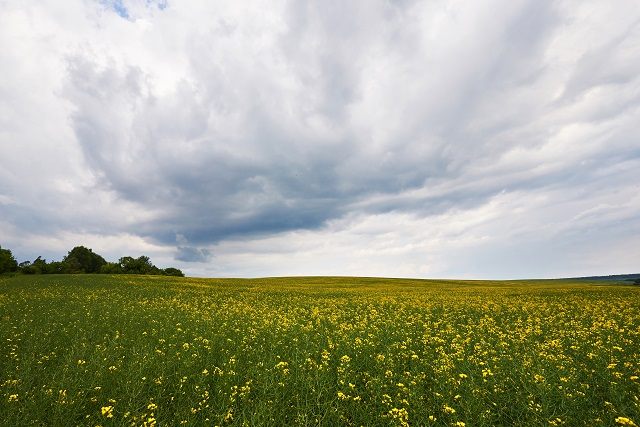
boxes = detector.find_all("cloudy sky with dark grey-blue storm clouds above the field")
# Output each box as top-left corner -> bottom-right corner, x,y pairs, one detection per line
0,0 -> 640,279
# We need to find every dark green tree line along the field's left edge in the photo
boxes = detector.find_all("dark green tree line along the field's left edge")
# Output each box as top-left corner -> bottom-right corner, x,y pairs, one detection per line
0,246 -> 184,277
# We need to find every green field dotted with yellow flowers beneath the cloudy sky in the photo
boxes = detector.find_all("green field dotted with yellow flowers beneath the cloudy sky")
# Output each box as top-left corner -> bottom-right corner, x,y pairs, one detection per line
0,275 -> 640,427
